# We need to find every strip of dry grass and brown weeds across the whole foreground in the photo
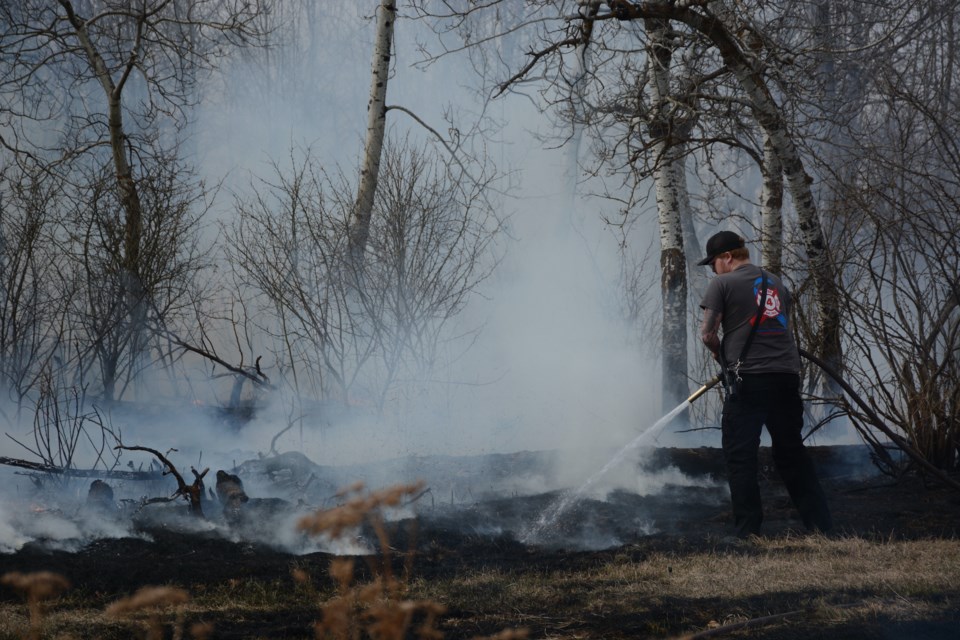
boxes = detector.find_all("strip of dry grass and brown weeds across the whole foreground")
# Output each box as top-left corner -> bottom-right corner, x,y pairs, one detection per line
0,492 -> 960,640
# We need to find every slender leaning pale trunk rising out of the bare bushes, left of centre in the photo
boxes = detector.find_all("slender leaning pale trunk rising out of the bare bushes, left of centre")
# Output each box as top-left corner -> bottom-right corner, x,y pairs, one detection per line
349,0 -> 397,267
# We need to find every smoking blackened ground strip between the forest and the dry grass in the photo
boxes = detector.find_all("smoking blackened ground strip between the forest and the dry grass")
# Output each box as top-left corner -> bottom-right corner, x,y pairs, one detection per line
0,446 -> 960,567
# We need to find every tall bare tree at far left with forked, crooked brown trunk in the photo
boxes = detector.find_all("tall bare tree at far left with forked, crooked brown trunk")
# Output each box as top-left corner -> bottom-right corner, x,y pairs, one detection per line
0,0 -> 264,399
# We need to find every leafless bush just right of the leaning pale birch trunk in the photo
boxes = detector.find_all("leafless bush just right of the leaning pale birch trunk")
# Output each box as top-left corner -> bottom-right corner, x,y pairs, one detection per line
363,140 -> 501,407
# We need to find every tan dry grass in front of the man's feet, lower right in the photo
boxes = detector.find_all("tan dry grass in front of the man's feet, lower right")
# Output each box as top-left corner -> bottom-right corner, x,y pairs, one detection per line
415,536 -> 960,638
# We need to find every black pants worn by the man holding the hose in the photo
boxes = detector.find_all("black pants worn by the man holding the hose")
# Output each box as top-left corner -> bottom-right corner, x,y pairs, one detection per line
721,373 -> 833,537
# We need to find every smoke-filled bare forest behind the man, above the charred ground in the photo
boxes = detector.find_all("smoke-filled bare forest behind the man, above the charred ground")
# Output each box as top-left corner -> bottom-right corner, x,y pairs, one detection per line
0,0 -> 960,480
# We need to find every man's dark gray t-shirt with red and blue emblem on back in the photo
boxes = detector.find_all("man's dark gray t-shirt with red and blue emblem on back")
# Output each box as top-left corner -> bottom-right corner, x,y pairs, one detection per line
700,264 -> 800,373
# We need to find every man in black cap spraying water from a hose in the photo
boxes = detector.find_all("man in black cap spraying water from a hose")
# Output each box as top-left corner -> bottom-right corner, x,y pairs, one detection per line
699,231 -> 832,538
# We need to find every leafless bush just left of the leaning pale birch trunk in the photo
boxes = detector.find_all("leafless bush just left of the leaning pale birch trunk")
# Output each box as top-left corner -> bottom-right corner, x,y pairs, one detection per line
225,152 -> 374,402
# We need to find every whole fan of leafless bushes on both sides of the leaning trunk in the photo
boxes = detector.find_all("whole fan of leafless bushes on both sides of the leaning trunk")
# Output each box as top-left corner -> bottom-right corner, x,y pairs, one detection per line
227,136 -> 499,416
